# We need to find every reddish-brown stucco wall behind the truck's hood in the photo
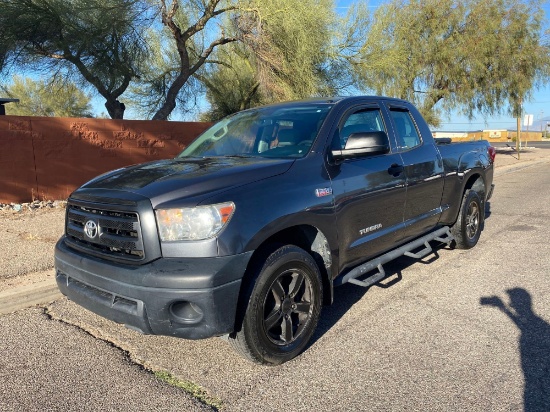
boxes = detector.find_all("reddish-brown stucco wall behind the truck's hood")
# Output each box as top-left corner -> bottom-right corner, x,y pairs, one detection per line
0,116 -> 209,203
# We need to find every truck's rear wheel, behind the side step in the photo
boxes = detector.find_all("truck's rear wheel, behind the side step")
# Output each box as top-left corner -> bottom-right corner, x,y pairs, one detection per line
451,189 -> 483,249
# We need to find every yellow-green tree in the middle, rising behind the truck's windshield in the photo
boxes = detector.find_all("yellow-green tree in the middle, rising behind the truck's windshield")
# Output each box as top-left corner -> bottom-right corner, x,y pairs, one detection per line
202,0 -> 366,120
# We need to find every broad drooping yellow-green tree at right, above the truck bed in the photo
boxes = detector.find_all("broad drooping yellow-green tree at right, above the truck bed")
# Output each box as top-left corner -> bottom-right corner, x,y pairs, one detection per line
351,0 -> 550,125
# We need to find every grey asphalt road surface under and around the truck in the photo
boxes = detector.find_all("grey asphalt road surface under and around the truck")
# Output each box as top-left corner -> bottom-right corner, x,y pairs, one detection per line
0,158 -> 550,411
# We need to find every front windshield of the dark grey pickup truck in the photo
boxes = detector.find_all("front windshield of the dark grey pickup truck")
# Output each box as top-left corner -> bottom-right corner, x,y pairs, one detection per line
178,104 -> 333,158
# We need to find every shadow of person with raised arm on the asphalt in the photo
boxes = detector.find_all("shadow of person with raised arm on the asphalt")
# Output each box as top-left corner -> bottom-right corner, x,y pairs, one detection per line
480,288 -> 550,412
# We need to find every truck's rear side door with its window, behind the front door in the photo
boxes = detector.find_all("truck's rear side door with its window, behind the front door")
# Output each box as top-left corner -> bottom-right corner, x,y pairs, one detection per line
387,104 -> 444,239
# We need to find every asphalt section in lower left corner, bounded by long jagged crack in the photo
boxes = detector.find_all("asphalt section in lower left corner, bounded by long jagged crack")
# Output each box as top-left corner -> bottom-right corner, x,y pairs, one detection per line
0,308 -> 211,412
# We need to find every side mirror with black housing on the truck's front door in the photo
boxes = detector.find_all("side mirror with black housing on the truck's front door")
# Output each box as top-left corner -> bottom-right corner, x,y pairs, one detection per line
332,132 -> 390,161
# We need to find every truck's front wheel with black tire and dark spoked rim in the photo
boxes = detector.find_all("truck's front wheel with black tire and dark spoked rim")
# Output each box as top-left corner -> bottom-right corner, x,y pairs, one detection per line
229,245 -> 323,365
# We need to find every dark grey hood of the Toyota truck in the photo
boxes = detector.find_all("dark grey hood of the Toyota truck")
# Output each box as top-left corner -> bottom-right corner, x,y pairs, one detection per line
81,157 -> 294,207
